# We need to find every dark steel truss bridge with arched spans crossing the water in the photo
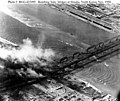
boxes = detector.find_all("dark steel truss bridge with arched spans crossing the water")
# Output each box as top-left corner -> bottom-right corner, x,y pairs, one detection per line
50,35 -> 120,77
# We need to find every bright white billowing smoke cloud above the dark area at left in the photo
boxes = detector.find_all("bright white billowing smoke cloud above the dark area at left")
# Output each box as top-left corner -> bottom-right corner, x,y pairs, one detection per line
0,38 -> 55,68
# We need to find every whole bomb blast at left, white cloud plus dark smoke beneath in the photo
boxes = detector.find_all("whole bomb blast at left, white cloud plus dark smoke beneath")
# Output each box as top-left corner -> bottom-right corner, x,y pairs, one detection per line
0,38 -> 55,99
